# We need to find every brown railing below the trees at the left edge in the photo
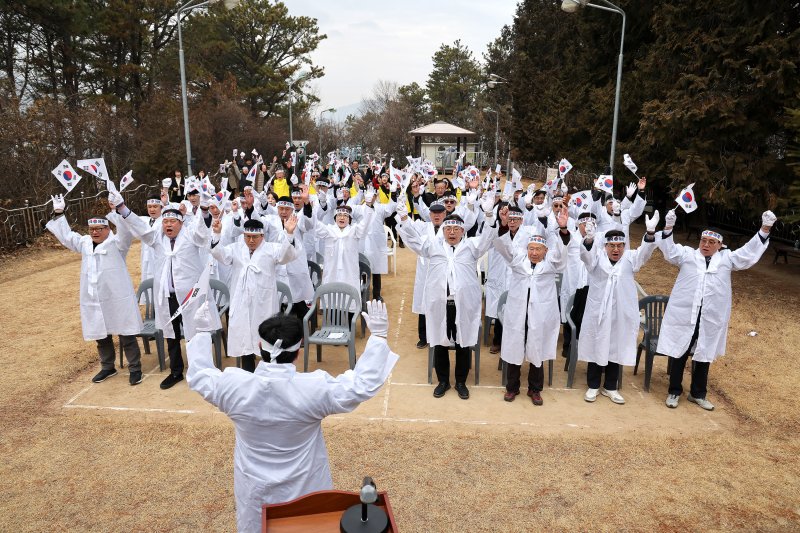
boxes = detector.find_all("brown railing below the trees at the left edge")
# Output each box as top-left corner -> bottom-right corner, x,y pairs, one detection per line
0,183 -> 159,252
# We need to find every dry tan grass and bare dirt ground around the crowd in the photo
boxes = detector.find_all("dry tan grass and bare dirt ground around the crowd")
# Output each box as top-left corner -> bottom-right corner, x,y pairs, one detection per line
0,222 -> 800,532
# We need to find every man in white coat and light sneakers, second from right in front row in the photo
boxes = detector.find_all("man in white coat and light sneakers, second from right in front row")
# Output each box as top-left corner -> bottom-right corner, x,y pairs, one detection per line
578,211 -> 659,404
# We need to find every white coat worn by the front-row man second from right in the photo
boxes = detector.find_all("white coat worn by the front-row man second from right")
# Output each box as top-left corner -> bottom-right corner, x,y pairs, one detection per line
578,238 -> 656,366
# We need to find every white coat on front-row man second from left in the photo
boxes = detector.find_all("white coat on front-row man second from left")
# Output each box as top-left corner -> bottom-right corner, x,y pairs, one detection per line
122,213 -> 222,340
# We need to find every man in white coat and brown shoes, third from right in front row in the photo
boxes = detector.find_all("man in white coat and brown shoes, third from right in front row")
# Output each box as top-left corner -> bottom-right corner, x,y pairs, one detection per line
494,204 -> 570,405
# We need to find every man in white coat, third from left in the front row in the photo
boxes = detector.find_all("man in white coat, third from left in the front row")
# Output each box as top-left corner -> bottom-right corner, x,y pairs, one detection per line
211,215 -> 298,372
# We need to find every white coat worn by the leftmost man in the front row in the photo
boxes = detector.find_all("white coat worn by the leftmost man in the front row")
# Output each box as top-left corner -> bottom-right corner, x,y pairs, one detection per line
47,216 -> 142,341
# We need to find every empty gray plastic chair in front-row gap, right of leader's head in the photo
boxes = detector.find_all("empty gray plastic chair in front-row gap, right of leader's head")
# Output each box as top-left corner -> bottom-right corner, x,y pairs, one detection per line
303,282 -> 361,372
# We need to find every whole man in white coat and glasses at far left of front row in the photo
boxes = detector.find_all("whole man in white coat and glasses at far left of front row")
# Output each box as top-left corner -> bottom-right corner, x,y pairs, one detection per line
46,195 -> 142,385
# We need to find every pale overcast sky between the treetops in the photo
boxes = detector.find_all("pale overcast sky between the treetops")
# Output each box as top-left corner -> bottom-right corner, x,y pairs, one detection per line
283,0 -> 517,118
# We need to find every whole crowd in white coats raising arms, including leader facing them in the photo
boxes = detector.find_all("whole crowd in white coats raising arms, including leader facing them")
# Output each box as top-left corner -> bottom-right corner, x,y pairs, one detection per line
47,151 -> 776,529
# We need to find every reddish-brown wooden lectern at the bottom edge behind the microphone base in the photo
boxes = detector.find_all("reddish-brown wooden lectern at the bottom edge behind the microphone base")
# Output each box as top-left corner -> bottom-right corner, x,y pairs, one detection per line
261,490 -> 397,533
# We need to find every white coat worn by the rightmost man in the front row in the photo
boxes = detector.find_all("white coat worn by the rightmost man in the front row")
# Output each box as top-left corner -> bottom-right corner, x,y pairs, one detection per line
656,232 -> 769,363
